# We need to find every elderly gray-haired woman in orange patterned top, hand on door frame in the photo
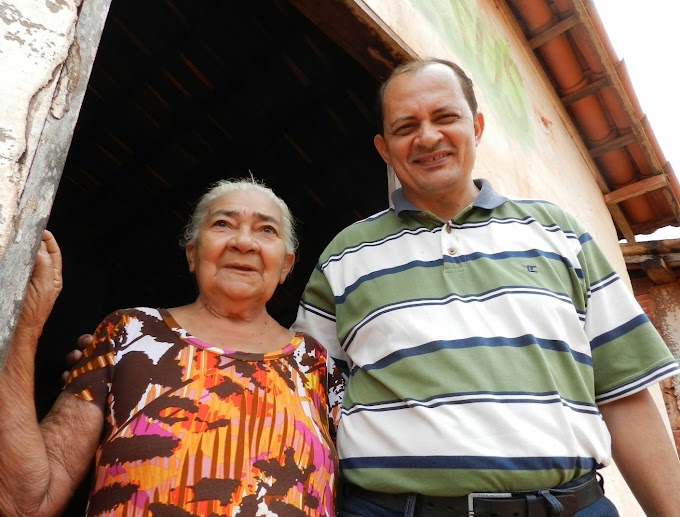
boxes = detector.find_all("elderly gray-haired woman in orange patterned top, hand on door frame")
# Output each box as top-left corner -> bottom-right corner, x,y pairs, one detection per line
0,180 -> 340,517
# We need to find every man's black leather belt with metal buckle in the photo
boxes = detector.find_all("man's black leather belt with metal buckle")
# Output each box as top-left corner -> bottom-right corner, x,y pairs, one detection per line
341,475 -> 603,517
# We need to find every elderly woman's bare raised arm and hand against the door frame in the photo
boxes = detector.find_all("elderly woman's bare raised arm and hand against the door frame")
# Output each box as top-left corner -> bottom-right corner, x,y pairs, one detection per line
0,232 -> 104,517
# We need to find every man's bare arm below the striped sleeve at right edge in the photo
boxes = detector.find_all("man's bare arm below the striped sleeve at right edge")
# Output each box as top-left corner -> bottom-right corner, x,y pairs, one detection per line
600,389 -> 680,517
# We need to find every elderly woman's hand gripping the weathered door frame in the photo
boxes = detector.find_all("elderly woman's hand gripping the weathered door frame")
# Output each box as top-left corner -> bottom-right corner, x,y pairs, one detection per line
18,230 -> 63,331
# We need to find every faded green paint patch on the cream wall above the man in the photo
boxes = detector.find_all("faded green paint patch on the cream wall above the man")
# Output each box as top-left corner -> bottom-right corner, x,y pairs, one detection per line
409,0 -> 534,147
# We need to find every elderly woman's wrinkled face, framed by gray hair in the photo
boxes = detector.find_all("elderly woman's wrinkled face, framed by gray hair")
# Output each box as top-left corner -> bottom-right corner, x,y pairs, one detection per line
186,191 -> 295,306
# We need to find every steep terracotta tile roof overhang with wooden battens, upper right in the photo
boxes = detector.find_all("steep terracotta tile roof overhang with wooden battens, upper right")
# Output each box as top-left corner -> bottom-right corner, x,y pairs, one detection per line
508,0 -> 680,242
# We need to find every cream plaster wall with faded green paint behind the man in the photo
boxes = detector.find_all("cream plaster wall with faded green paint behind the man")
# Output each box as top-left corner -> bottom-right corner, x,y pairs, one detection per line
364,0 -> 668,517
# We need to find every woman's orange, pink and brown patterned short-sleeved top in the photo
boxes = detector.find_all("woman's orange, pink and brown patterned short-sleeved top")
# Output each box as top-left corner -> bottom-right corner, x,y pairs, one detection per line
65,308 -> 342,517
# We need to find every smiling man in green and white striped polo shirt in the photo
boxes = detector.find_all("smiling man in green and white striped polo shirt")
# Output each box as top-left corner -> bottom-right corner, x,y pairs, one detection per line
296,59 -> 680,517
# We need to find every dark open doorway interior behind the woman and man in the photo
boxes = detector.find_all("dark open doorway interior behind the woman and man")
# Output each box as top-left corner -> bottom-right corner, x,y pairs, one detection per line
36,0 -> 387,515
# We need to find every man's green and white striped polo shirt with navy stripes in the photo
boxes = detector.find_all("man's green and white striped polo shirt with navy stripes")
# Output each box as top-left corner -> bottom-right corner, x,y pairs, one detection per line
295,180 -> 680,496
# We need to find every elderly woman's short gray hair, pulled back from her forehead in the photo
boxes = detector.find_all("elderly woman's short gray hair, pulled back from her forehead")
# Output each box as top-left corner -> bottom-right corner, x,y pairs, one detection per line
180,177 -> 298,253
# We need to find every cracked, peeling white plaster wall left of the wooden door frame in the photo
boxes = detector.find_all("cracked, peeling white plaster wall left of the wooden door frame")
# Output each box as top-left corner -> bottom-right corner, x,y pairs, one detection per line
0,0 -> 82,258
